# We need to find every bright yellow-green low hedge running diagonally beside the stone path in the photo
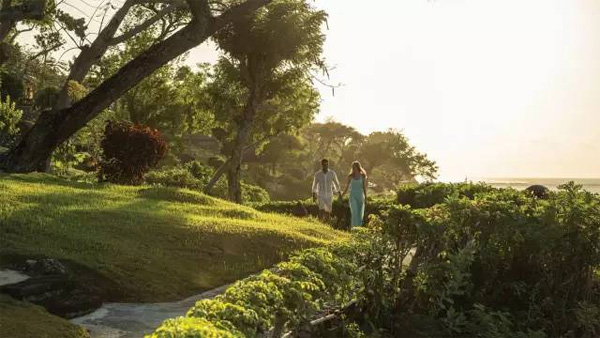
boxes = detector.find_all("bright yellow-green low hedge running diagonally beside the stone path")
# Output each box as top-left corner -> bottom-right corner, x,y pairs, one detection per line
150,247 -> 358,337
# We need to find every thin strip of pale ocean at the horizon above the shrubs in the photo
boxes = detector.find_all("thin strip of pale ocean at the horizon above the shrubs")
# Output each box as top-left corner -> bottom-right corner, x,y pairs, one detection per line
469,178 -> 600,194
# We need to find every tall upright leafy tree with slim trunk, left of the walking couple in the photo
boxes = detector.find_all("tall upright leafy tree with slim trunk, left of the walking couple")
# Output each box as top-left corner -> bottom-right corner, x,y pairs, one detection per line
205,0 -> 326,203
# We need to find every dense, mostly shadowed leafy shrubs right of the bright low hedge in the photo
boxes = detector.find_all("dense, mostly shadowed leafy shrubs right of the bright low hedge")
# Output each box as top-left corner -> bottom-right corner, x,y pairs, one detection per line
359,183 -> 600,337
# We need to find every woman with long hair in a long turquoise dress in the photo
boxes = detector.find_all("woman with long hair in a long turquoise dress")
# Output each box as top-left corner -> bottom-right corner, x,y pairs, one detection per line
343,161 -> 367,227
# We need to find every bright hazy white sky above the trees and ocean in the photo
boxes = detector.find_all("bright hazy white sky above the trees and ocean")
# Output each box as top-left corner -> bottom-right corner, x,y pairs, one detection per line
34,0 -> 600,181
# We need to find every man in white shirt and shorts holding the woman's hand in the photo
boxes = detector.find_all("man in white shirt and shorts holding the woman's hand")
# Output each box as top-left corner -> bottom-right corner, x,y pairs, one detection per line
312,159 -> 342,222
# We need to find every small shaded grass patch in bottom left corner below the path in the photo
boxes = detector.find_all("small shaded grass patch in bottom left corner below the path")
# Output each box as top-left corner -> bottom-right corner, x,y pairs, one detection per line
0,294 -> 89,338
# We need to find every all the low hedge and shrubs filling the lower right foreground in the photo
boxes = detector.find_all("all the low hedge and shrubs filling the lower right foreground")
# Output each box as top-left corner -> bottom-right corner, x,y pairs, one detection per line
153,183 -> 600,338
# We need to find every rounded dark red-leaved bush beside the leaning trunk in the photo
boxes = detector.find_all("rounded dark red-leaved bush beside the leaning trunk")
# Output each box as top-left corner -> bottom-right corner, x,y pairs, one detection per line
98,121 -> 168,185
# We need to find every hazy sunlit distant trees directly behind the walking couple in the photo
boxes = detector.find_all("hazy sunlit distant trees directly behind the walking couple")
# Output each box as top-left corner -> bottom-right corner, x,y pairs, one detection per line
246,121 -> 437,200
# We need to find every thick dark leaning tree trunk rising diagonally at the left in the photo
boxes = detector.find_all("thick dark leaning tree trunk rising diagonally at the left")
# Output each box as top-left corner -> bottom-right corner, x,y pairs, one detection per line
0,0 -> 270,172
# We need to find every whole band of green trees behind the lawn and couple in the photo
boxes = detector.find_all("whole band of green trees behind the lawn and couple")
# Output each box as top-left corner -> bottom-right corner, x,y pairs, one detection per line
0,0 -> 437,202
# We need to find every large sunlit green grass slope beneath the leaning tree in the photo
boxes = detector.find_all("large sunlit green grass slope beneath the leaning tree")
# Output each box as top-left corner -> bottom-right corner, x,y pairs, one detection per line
0,174 -> 347,301
